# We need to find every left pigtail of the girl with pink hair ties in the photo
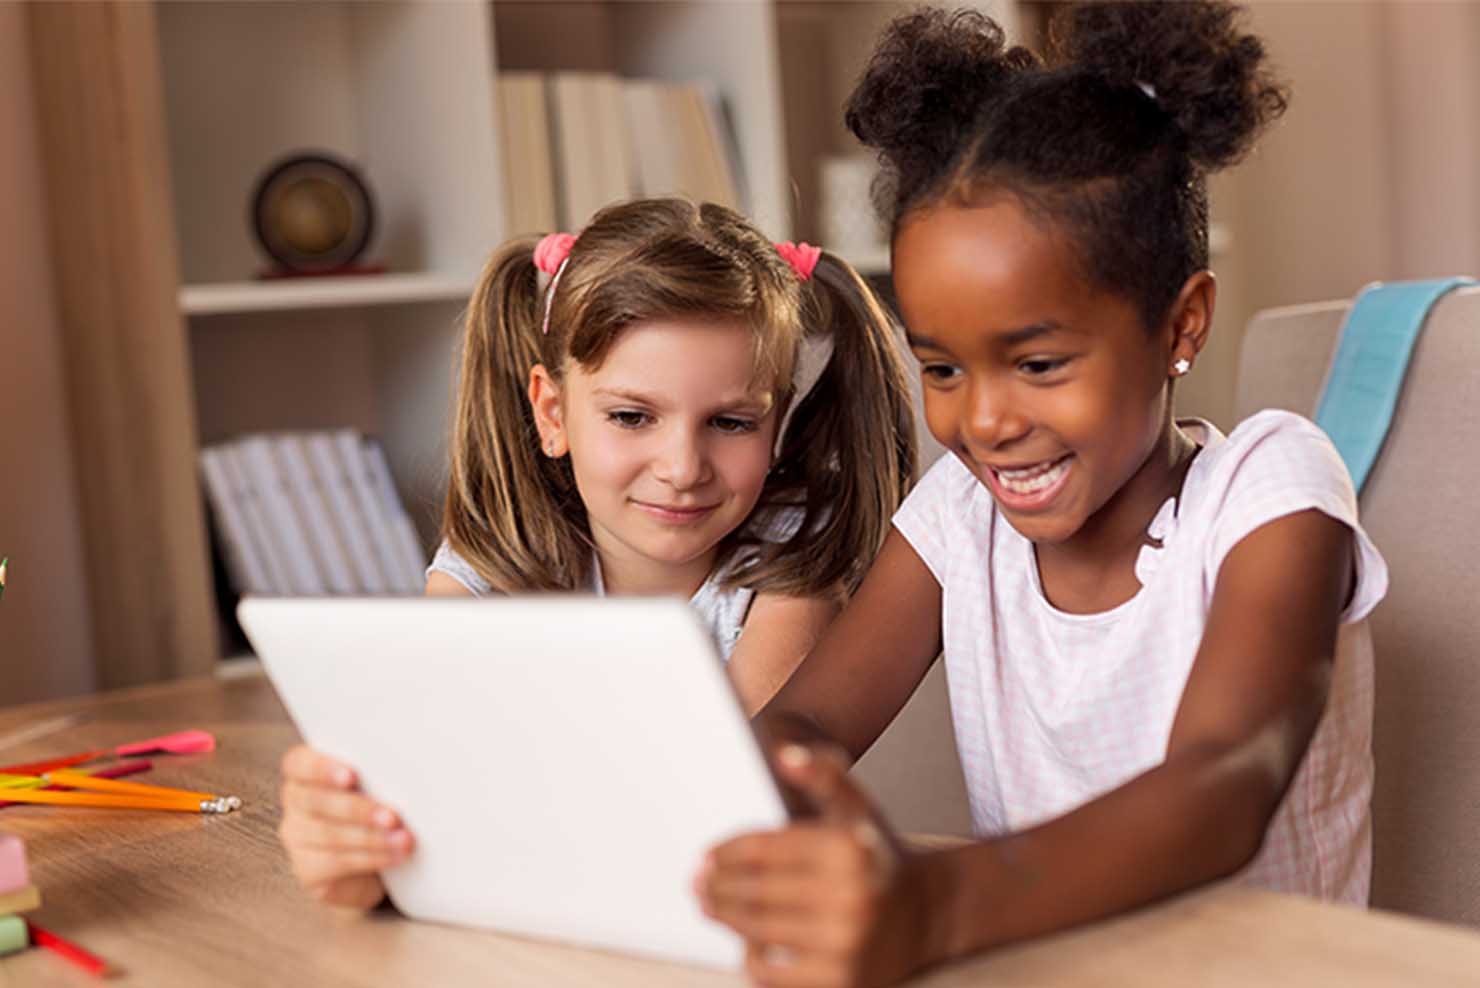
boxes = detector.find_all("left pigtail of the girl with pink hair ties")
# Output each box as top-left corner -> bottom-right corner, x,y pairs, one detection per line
443,240 -> 591,593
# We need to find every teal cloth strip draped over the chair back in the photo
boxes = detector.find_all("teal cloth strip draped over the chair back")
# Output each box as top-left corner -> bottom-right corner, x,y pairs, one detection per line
1316,278 -> 1476,494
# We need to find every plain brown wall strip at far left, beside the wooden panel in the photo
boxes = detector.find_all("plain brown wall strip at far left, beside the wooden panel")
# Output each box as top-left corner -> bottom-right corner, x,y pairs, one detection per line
0,1 -> 95,707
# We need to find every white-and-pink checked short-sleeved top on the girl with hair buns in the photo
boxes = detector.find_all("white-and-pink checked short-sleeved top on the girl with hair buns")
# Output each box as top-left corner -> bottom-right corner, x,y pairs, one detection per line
894,411 -> 1387,904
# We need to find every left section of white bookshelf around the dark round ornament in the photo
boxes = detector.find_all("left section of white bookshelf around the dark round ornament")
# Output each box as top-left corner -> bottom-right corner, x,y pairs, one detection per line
157,0 -> 503,562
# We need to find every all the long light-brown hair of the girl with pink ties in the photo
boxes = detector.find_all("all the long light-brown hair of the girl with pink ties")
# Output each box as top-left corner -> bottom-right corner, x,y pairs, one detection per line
443,198 -> 915,596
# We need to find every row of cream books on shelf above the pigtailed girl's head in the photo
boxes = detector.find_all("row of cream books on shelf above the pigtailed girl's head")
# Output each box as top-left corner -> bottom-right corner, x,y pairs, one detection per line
497,72 -> 743,234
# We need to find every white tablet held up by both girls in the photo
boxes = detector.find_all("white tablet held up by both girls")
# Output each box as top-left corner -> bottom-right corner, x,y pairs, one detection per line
237,595 -> 786,967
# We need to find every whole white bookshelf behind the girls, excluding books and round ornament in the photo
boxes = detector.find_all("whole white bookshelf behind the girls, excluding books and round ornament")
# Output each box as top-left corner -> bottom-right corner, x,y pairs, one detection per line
155,0 -> 1024,647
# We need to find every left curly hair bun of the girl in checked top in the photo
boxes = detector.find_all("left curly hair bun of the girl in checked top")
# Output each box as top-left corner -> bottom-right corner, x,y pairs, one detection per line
845,7 -> 1037,213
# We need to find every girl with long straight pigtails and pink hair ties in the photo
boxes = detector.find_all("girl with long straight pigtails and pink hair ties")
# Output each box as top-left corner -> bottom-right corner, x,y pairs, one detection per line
280,200 -> 915,908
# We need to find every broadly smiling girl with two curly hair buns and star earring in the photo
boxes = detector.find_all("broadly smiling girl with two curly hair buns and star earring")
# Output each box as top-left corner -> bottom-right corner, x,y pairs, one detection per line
697,3 -> 1387,985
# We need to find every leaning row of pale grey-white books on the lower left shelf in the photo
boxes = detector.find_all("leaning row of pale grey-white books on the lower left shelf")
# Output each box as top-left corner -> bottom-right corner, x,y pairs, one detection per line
200,429 -> 426,596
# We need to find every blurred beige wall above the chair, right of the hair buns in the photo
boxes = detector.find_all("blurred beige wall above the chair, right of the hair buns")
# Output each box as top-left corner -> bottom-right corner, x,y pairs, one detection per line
1178,3 -> 1480,427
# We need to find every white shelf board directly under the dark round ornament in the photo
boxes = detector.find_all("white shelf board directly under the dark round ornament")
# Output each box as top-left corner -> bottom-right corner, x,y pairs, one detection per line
179,272 -> 474,315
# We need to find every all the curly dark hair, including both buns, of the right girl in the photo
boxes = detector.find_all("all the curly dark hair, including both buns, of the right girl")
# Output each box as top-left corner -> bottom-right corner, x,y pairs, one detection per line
847,0 -> 1289,328
